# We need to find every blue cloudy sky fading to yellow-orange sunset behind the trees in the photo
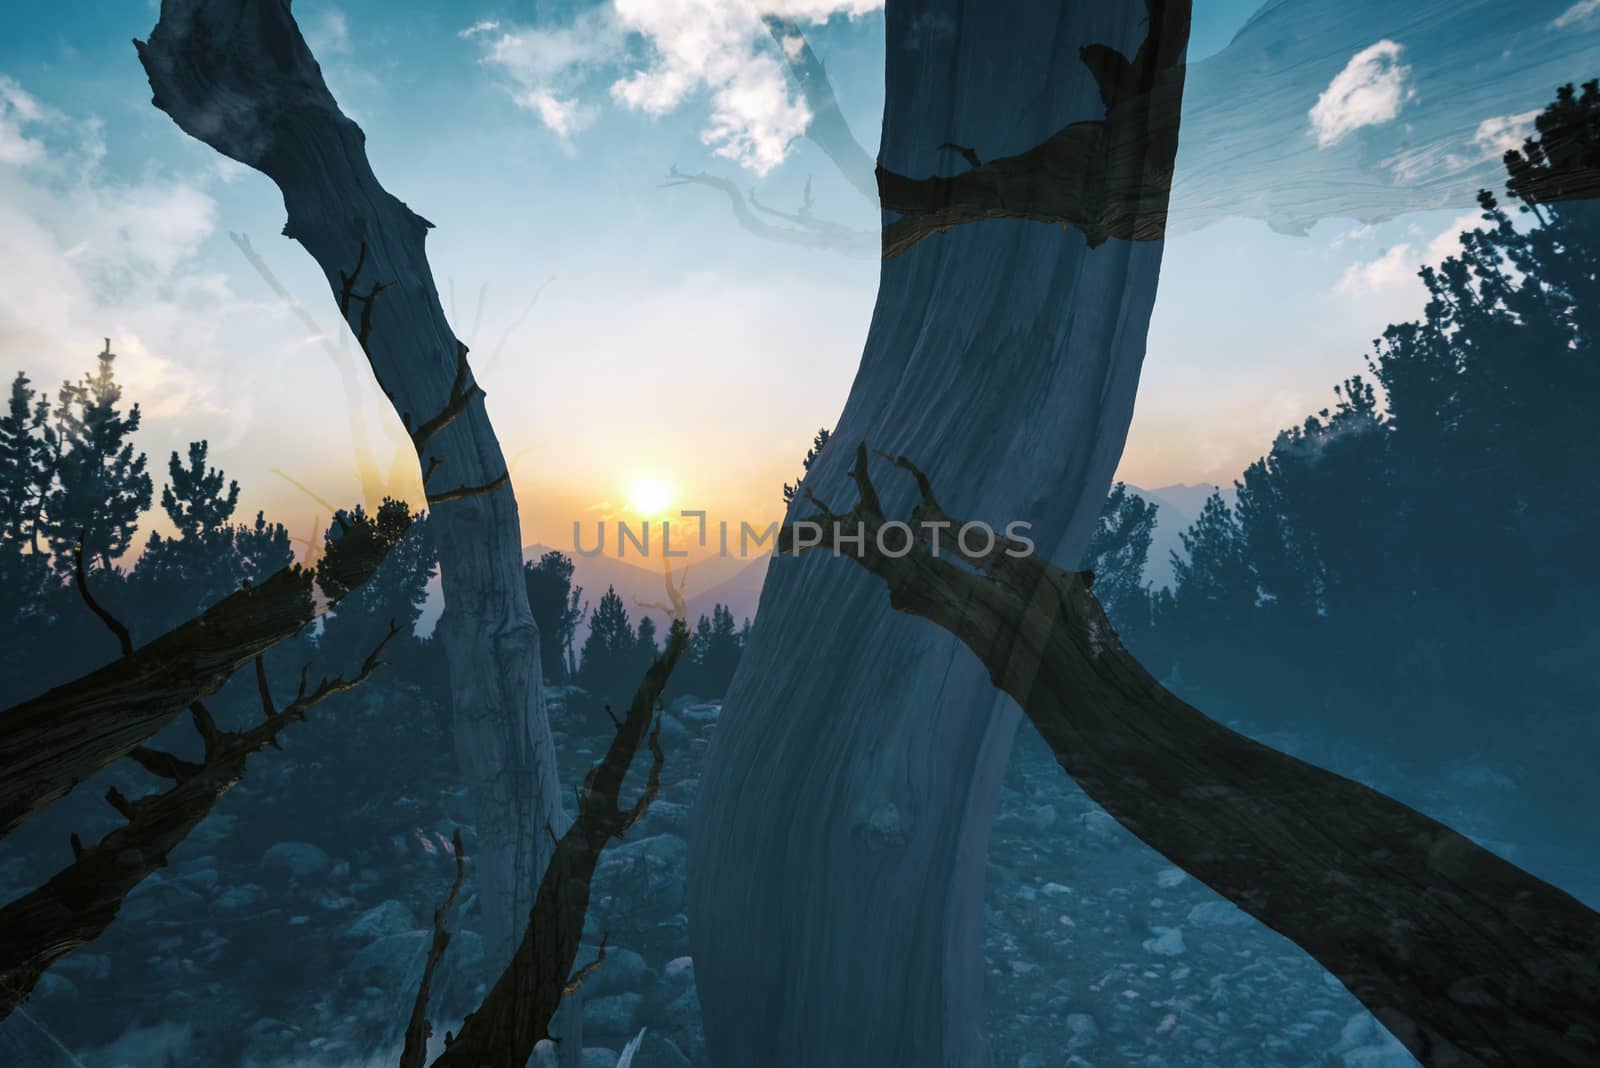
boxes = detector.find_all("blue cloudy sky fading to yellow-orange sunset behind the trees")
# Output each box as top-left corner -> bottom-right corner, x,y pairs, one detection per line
0,0 -> 1600,562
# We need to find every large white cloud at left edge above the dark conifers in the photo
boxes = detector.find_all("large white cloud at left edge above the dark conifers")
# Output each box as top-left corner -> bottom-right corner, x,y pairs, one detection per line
0,80 -> 250,441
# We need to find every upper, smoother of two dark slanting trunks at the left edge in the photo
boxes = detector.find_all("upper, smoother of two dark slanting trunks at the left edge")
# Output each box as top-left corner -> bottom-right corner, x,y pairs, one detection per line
0,505 -> 411,838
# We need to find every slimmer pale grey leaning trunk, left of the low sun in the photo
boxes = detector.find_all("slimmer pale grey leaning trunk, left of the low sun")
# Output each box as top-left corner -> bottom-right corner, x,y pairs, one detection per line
136,0 -> 565,974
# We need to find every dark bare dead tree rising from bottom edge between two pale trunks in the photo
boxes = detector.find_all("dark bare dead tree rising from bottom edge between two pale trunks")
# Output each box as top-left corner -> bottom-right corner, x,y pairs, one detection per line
416,620 -> 690,1068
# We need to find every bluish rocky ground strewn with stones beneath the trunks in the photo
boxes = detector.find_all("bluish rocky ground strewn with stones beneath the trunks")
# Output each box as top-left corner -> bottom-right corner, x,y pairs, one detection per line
0,674 -> 1555,1068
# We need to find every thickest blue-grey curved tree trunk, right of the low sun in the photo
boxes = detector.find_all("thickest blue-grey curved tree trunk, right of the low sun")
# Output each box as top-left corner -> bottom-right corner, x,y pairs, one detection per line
688,0 -> 1189,1066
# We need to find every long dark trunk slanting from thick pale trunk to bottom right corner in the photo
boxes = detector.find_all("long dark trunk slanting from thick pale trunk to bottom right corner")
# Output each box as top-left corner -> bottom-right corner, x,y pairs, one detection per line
779,446 -> 1600,1066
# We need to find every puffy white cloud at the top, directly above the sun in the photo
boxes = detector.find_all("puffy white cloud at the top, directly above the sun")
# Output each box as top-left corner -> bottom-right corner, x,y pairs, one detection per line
461,0 -> 883,174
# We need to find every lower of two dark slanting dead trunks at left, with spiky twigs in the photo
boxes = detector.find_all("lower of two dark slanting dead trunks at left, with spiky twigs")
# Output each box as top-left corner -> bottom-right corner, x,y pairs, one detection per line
0,627 -> 398,1020
